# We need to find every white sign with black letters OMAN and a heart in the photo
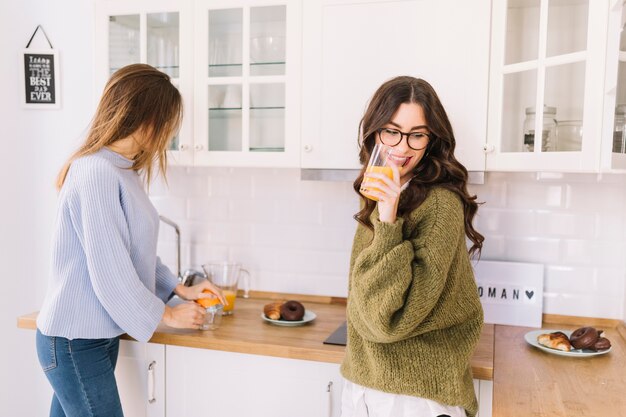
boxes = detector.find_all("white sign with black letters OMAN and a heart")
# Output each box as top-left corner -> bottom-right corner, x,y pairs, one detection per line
474,261 -> 544,327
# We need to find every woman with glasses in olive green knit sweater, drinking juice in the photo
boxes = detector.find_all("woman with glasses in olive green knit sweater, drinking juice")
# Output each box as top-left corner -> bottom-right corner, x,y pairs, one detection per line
341,77 -> 484,417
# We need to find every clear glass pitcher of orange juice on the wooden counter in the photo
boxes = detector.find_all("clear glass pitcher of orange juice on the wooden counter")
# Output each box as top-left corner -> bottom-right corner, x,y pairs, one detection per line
202,261 -> 250,315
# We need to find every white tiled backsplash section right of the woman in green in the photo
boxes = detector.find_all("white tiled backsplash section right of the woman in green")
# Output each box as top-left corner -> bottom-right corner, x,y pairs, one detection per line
470,173 -> 626,319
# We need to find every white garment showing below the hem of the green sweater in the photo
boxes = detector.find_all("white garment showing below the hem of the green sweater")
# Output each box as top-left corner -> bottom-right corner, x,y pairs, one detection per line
341,379 -> 466,417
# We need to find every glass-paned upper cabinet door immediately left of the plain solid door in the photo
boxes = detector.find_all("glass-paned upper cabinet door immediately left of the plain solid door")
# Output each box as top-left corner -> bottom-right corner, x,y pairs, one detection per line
194,0 -> 300,167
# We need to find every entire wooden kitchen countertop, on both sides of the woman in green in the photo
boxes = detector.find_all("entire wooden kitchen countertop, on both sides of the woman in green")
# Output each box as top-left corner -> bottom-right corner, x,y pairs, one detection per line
18,292 -> 626,417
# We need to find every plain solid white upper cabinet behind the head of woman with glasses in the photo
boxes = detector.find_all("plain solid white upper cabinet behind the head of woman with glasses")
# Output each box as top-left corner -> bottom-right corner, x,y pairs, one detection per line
301,0 -> 491,171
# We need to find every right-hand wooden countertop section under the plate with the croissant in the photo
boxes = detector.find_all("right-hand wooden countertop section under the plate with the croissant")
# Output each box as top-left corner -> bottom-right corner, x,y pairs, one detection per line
493,319 -> 626,417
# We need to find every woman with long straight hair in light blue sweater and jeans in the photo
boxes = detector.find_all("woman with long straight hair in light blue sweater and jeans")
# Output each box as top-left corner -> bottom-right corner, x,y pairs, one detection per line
36,64 -> 225,417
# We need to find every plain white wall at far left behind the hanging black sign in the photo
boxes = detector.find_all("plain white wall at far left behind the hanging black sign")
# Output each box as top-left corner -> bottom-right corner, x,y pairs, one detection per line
0,0 -> 93,417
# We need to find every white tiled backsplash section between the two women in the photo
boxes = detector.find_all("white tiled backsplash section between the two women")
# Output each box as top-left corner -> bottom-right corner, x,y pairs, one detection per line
150,167 -> 358,296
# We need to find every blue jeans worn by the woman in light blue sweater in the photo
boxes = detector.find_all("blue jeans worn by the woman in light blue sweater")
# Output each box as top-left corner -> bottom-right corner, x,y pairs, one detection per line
36,329 -> 124,417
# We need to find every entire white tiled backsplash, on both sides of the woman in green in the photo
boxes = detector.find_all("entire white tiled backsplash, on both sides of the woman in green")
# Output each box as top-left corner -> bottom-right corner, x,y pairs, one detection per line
151,167 -> 626,318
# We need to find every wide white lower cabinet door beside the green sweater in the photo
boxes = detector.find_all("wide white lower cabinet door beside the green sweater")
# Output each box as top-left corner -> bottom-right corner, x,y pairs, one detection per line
166,346 -> 342,417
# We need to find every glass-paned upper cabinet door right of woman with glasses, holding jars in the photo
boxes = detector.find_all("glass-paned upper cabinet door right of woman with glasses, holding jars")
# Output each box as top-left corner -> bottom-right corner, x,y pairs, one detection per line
485,0 -> 608,172
